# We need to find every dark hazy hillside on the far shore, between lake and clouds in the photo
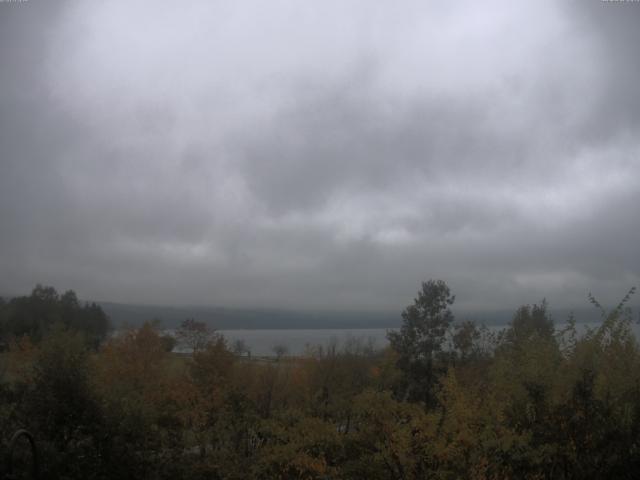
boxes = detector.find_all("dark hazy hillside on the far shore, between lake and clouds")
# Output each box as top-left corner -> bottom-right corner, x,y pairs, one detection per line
98,302 -> 637,330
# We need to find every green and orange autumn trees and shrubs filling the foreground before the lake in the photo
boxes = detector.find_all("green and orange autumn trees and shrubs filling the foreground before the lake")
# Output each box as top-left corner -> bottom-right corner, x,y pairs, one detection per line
0,281 -> 640,480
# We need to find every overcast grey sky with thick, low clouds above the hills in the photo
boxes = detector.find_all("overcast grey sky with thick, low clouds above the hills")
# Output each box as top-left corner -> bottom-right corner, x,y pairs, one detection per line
0,0 -> 640,311
